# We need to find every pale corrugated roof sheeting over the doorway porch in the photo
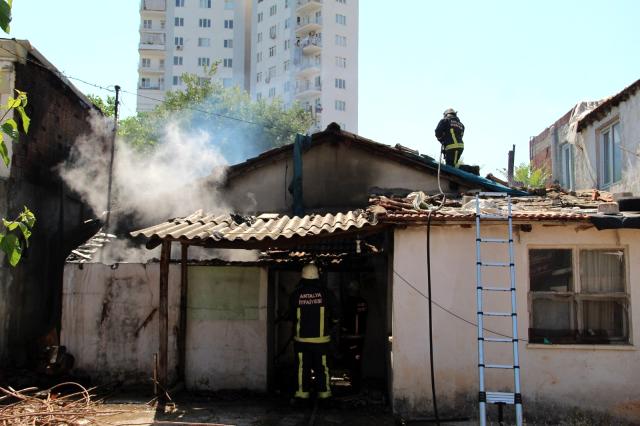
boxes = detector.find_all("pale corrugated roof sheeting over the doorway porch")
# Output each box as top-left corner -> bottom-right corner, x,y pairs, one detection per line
131,210 -> 377,242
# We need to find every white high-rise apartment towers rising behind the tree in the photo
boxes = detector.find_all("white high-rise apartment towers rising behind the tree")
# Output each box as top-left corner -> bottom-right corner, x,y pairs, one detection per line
138,0 -> 358,132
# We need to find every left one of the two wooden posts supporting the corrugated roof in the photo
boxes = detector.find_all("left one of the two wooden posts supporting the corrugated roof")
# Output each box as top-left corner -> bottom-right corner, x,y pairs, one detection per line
158,241 -> 171,391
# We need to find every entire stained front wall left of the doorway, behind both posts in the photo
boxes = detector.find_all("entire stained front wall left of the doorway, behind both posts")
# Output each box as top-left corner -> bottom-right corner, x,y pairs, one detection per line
61,263 -> 267,390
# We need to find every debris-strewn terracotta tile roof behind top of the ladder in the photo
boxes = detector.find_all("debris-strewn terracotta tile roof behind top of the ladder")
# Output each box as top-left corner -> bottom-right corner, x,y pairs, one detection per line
370,191 -> 609,223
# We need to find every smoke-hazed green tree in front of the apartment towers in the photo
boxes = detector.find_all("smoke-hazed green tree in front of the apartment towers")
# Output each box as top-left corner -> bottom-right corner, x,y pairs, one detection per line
119,65 -> 313,156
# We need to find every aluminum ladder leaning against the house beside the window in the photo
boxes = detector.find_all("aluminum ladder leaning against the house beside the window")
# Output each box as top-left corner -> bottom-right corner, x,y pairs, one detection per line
476,192 -> 522,426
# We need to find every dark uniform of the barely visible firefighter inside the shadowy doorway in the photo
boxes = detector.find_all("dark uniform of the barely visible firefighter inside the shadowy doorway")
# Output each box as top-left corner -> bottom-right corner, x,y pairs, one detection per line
341,295 -> 369,392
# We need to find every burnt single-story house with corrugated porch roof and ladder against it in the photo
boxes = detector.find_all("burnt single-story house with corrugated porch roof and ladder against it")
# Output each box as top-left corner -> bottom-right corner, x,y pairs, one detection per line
62,126 -> 640,417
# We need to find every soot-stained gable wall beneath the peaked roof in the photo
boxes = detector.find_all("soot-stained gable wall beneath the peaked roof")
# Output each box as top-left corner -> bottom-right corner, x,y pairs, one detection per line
224,142 -> 466,212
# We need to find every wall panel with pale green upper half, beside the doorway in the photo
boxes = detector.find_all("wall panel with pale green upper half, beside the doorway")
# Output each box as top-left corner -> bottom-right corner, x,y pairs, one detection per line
185,266 -> 268,391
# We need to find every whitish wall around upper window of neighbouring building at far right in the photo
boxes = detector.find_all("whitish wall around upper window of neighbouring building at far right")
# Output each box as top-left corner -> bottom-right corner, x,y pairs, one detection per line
575,92 -> 640,195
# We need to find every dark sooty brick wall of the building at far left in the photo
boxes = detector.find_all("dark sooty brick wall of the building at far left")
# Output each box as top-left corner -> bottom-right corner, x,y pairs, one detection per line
0,45 -> 95,366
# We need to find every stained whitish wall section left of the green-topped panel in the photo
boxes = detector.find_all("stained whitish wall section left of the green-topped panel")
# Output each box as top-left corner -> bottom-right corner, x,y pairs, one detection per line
60,263 -> 180,383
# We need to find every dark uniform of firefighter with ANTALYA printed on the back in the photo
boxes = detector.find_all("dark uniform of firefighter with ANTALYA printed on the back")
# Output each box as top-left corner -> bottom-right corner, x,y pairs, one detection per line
289,279 -> 339,399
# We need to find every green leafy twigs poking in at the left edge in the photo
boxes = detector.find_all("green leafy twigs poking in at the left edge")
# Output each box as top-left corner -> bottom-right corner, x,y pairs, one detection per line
0,0 -> 36,266
